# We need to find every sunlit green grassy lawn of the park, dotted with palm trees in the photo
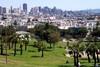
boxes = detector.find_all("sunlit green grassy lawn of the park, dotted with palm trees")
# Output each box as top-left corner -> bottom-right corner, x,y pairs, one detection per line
0,41 -> 99,67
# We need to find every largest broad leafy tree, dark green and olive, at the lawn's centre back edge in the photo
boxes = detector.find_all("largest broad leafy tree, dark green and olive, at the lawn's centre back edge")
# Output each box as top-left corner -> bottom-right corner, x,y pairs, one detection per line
35,23 -> 60,47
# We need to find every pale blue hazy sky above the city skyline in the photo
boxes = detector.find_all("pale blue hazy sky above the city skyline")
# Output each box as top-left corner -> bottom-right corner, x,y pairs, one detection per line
0,0 -> 100,10
